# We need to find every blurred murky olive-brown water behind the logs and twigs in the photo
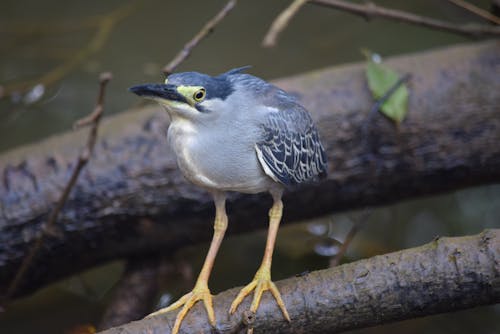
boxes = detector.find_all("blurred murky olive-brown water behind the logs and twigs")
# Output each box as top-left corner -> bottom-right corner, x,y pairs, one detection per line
0,0 -> 500,333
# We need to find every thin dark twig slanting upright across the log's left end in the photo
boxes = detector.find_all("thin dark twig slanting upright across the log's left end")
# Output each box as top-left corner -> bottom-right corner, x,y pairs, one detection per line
4,73 -> 111,302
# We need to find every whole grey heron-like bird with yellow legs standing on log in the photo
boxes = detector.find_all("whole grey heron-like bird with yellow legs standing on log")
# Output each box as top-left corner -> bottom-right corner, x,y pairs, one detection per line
129,66 -> 328,334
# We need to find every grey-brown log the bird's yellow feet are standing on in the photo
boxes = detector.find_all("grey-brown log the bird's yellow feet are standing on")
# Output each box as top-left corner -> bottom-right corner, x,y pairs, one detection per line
97,230 -> 500,334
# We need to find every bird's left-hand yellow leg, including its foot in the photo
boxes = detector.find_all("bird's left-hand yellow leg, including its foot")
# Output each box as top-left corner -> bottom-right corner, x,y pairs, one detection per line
148,193 -> 227,334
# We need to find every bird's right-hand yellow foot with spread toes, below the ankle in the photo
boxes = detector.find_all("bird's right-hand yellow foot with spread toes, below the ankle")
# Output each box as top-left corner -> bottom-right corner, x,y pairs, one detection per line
229,265 -> 290,321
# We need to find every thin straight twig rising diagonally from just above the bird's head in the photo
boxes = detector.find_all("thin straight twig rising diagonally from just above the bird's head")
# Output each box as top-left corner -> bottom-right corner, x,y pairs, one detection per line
162,0 -> 237,76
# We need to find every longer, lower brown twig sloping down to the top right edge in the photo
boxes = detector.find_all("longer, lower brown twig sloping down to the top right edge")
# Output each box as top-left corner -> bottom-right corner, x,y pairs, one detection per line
309,0 -> 500,37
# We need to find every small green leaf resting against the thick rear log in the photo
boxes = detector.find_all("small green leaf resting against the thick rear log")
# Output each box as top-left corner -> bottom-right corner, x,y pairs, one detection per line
366,56 -> 409,124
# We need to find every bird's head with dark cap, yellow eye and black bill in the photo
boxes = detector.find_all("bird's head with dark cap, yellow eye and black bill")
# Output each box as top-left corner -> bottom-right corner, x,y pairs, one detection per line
129,66 -> 254,120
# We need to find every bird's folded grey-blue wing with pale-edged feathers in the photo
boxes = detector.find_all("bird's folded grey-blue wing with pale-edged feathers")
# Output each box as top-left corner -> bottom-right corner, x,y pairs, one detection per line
256,103 -> 327,186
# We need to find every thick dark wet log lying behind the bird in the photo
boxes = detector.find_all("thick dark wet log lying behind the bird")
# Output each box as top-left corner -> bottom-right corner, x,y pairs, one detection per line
0,41 -> 500,296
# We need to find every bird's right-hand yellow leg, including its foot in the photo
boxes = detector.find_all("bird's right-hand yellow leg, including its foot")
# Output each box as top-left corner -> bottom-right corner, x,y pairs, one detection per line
229,191 -> 290,321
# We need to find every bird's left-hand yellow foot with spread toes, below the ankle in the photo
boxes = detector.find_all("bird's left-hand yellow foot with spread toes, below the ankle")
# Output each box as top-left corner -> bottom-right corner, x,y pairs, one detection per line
147,281 -> 215,334
